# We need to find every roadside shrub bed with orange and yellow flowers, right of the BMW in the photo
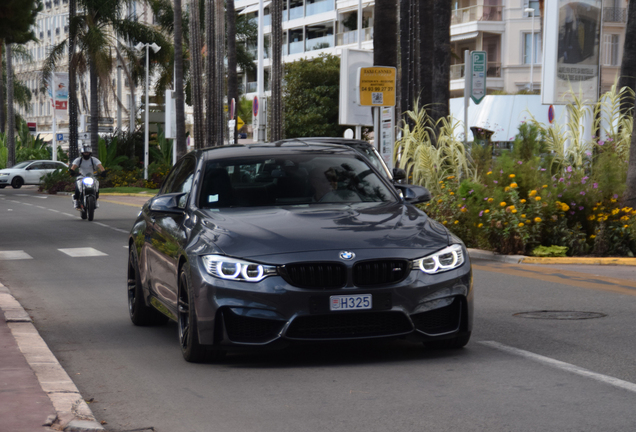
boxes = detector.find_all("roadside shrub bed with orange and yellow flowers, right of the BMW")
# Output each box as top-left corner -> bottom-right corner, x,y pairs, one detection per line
418,88 -> 636,256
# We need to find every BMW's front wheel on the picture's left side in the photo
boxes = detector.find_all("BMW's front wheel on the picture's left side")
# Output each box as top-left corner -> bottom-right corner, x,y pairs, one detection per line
177,264 -> 225,363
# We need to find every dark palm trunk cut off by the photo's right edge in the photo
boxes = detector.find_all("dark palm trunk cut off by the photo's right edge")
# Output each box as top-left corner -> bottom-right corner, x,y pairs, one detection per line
618,0 -> 636,207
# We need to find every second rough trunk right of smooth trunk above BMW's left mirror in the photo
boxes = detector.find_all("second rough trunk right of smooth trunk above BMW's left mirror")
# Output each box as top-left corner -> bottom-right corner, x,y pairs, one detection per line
205,0 -> 220,147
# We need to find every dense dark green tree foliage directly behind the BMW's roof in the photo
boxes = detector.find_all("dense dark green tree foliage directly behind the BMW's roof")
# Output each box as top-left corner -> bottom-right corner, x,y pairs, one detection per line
283,55 -> 346,138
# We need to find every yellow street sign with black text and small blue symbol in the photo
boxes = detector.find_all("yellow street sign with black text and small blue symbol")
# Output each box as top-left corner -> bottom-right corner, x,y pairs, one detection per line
358,66 -> 396,106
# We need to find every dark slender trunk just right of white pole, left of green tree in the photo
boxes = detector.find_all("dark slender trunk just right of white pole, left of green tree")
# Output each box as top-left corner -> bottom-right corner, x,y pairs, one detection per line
270,0 -> 283,141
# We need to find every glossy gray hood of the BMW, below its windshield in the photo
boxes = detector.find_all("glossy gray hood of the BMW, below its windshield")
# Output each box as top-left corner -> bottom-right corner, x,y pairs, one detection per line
199,202 -> 449,258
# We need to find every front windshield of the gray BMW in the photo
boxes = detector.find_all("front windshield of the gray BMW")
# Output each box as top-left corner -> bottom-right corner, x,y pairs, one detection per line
200,152 -> 395,208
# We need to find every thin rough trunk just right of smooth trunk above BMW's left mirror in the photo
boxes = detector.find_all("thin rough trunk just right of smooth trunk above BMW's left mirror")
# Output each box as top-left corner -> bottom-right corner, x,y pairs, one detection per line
190,0 -> 205,149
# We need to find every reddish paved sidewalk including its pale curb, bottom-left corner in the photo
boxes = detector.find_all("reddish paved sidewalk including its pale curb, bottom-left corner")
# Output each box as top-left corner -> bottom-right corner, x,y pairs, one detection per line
0,284 -> 104,432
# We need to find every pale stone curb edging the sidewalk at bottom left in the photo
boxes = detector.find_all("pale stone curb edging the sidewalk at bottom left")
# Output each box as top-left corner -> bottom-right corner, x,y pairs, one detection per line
0,283 -> 105,432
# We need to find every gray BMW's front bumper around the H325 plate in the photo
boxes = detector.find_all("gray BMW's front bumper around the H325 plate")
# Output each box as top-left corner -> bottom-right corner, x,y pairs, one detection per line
191,260 -> 473,348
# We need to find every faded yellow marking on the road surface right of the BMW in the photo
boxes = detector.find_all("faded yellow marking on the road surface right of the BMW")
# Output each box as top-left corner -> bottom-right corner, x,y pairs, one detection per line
473,264 -> 636,296
